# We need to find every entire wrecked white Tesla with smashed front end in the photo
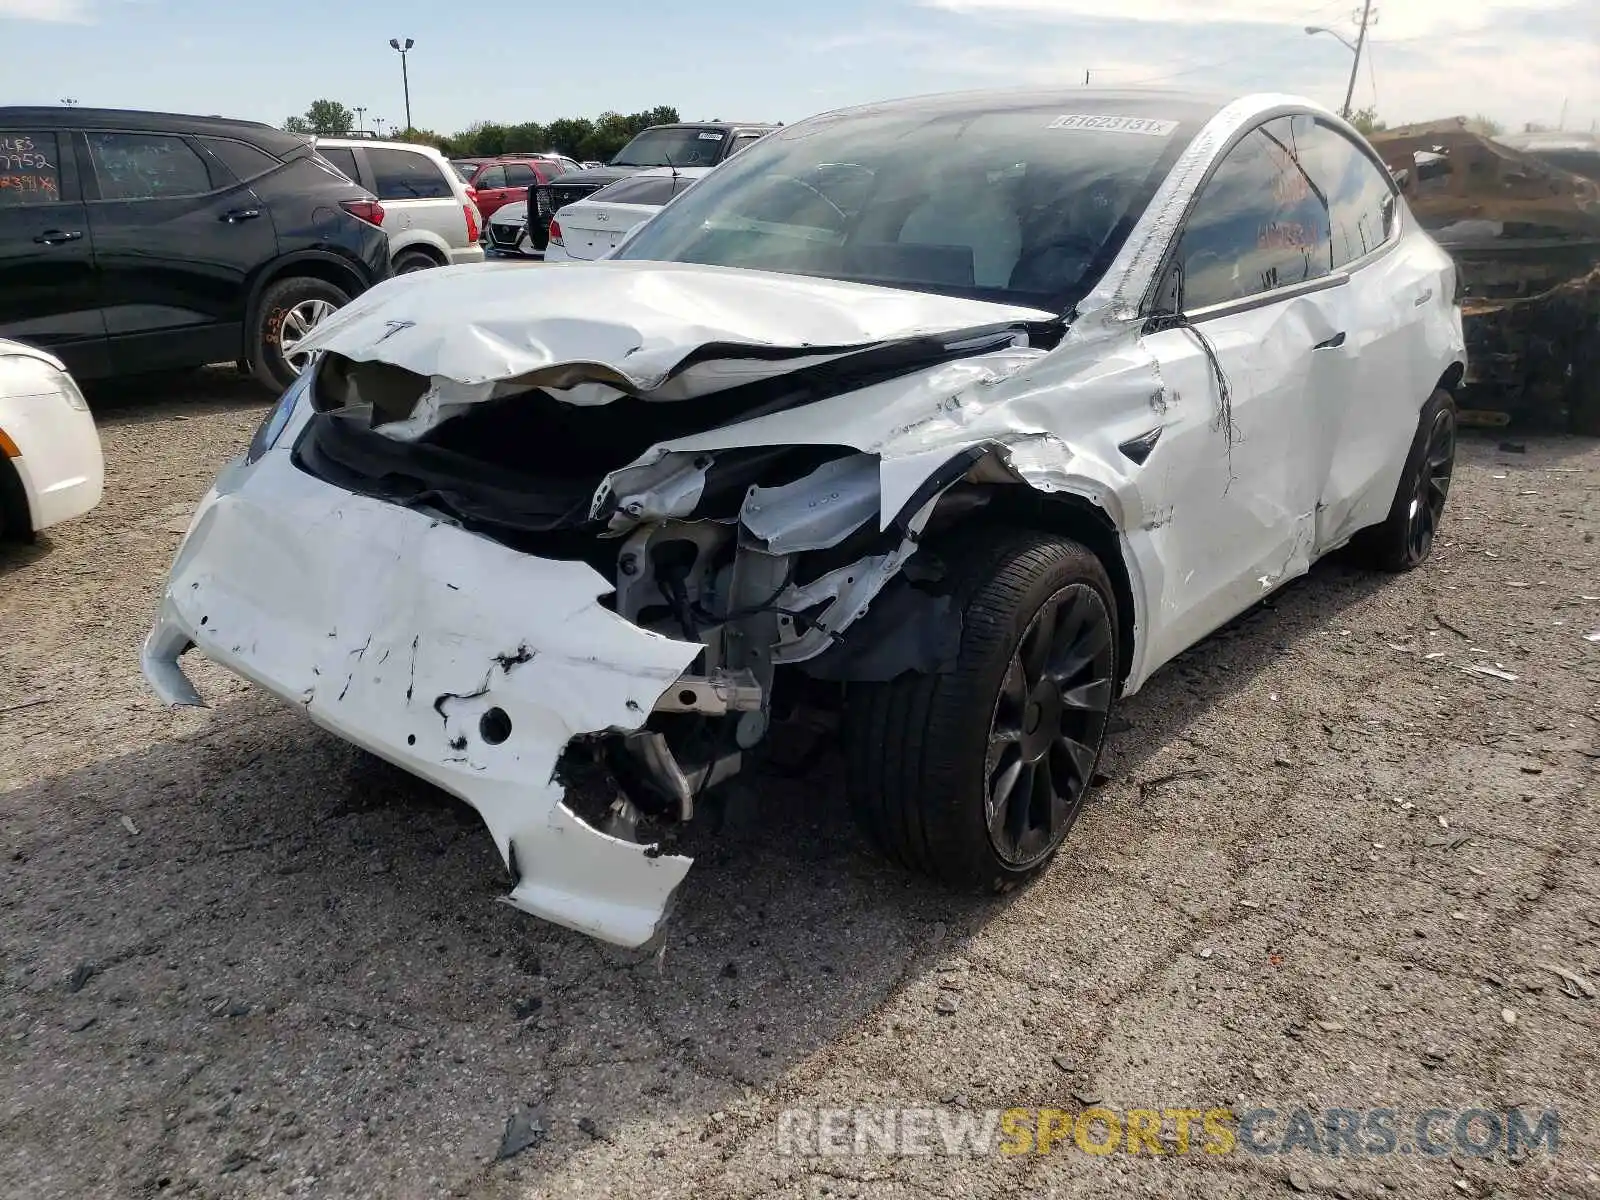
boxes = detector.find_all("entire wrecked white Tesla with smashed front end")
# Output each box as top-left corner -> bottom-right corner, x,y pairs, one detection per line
144,90 -> 1464,946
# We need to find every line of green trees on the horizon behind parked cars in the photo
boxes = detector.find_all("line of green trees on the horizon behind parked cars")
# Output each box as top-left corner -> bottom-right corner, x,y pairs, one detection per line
283,99 -> 680,162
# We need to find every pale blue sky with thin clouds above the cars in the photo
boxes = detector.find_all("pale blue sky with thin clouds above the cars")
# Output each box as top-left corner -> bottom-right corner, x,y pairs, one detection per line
0,0 -> 1600,131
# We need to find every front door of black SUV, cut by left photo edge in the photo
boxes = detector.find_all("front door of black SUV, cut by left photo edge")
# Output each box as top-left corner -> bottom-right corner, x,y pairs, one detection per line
0,128 -> 107,376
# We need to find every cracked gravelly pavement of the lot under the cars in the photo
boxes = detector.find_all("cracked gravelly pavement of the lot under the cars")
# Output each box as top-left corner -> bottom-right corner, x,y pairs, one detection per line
0,374 -> 1600,1200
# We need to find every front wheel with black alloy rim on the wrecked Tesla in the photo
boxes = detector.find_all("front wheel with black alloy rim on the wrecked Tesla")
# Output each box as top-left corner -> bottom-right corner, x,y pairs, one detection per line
846,530 -> 1118,891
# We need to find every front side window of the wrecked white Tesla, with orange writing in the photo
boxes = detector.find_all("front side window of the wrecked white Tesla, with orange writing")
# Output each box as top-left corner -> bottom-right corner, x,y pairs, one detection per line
1174,118 -> 1331,309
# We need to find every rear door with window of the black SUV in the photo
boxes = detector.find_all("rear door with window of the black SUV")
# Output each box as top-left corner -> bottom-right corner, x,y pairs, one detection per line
78,130 -> 278,371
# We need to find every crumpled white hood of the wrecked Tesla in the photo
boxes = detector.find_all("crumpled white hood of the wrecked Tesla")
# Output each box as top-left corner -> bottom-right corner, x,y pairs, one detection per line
306,261 -> 1059,403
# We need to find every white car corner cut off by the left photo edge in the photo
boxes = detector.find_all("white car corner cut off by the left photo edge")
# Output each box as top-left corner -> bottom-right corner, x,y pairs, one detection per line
0,338 -> 106,538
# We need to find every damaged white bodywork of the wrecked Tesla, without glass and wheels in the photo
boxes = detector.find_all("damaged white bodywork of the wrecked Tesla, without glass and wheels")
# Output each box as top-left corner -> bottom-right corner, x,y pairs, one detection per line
144,86 -> 1461,944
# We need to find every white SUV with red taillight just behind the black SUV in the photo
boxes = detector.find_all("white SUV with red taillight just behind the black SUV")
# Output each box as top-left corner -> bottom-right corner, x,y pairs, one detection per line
317,138 -> 483,275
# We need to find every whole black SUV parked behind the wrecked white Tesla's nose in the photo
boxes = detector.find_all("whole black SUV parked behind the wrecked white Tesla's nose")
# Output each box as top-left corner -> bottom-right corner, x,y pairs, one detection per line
0,107 -> 389,390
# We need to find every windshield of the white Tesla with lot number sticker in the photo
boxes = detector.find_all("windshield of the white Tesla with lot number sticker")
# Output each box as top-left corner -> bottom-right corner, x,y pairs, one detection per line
616,96 -> 1214,312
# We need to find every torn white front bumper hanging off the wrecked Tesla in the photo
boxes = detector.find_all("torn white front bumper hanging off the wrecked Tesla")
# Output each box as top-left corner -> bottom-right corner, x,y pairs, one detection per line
141,450 -> 699,946
